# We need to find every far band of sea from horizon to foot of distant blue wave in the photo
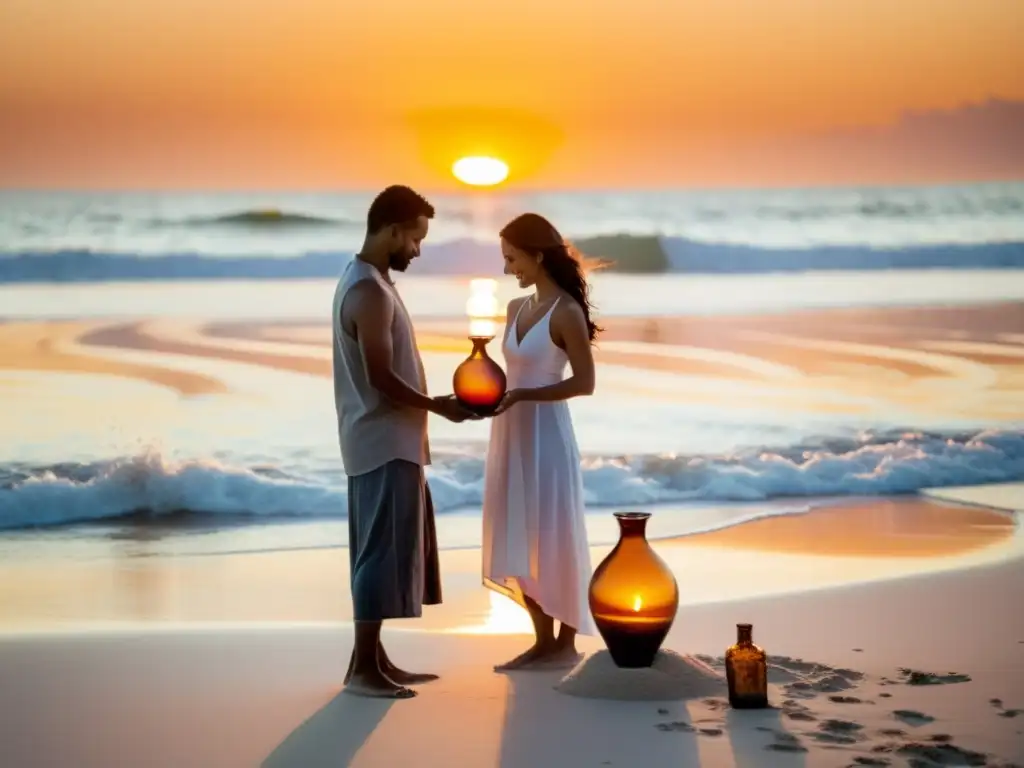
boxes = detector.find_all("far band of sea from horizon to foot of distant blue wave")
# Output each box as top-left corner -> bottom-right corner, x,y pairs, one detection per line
6,183 -> 1024,283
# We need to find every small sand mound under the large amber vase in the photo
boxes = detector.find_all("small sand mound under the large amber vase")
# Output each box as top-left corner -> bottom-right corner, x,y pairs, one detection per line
555,650 -> 725,701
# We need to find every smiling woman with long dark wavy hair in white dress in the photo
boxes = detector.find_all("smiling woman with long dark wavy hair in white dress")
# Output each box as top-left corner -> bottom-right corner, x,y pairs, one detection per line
483,213 -> 600,671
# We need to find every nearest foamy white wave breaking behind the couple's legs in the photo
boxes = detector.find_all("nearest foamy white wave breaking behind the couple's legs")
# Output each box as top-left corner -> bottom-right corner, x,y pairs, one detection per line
0,429 -> 1024,529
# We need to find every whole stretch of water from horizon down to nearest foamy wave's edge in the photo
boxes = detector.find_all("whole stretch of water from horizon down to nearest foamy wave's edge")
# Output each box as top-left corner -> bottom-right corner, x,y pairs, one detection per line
0,183 -> 1024,556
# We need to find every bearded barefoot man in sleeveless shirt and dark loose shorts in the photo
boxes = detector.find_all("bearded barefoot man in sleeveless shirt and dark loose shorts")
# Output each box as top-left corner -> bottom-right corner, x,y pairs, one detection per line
333,186 -> 479,698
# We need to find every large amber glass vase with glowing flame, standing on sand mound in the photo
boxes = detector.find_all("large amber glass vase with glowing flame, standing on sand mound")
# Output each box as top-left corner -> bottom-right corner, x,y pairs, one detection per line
590,512 -> 679,669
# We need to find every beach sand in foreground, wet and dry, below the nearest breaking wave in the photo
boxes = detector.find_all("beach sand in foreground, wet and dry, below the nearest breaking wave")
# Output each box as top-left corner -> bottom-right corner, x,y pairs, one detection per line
0,487 -> 1024,768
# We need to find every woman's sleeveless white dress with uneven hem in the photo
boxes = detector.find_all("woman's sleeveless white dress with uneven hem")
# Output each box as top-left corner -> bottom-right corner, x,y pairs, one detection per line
483,299 -> 595,635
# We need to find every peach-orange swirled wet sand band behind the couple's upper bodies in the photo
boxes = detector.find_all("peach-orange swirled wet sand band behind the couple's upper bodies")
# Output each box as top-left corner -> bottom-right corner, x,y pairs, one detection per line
0,303 -> 1024,422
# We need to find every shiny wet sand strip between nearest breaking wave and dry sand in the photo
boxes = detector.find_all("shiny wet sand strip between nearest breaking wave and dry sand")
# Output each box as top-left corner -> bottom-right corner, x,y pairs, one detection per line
0,497 -> 1024,634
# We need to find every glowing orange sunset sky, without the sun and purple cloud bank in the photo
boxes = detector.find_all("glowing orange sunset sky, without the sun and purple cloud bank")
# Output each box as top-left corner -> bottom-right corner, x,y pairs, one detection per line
0,0 -> 1024,188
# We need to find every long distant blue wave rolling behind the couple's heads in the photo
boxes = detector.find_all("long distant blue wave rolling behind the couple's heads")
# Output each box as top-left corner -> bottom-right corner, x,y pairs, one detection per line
0,234 -> 1024,283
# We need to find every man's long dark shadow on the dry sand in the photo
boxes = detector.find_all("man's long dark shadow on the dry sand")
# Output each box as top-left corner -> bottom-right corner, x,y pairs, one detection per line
260,692 -> 394,768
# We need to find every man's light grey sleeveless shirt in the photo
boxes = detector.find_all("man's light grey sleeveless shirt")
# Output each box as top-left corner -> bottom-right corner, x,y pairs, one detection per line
332,258 -> 430,477
